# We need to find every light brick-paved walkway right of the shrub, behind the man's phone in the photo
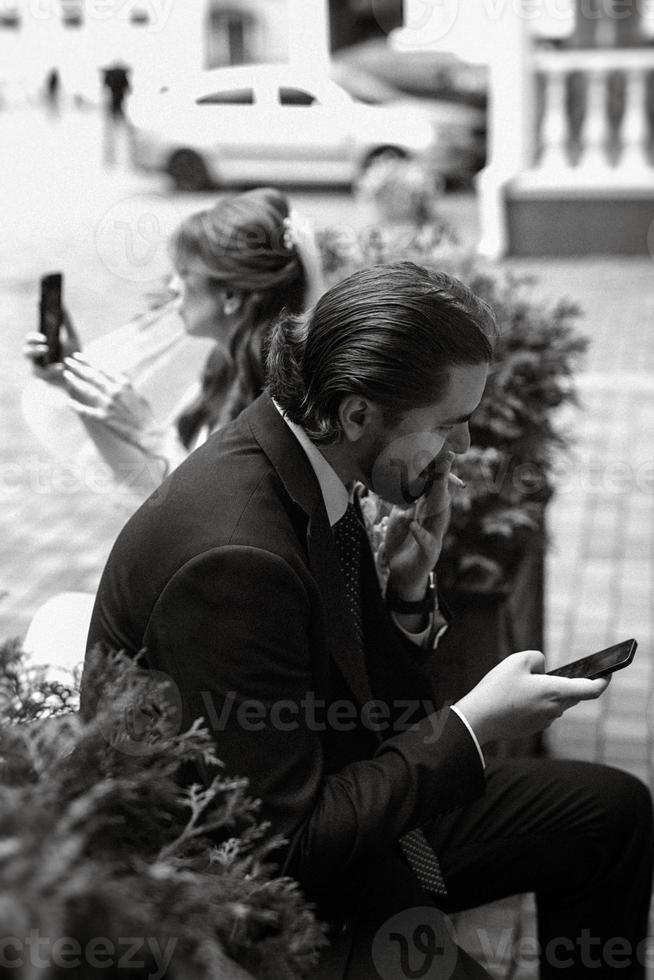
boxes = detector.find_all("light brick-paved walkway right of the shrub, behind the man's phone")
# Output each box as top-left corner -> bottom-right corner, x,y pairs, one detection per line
513,259 -> 654,788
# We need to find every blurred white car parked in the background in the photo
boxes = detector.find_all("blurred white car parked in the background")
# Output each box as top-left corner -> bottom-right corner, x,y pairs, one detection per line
128,64 -> 444,190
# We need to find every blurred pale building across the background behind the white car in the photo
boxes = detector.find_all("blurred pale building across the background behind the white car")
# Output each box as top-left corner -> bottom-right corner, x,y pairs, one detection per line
0,0 -> 394,102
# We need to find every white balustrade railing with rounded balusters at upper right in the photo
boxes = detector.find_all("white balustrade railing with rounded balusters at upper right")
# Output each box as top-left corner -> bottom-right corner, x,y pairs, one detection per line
532,48 -> 654,178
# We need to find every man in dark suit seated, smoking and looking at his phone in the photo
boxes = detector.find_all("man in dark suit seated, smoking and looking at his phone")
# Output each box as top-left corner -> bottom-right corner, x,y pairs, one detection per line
82,263 -> 652,980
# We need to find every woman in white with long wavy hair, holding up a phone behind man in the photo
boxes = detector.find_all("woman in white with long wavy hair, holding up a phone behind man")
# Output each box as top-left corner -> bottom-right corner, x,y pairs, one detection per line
25,188 -> 322,497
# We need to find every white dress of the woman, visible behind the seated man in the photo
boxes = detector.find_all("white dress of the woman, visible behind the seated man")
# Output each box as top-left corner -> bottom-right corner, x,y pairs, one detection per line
22,302 -> 213,681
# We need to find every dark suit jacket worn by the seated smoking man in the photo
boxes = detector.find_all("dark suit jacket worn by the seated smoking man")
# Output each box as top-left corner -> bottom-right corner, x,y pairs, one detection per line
82,394 -> 484,936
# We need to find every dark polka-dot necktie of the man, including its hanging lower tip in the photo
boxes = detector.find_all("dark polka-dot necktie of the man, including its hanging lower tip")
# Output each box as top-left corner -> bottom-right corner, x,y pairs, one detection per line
333,504 -> 447,897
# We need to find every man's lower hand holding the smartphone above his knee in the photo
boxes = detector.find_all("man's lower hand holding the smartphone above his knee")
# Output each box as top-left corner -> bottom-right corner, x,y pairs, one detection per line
456,650 -> 609,745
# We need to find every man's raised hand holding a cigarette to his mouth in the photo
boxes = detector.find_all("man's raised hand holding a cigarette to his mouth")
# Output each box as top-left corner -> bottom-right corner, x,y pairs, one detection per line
384,452 -> 454,602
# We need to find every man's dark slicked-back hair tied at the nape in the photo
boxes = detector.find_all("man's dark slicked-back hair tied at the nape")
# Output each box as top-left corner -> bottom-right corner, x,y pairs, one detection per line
268,262 -> 497,443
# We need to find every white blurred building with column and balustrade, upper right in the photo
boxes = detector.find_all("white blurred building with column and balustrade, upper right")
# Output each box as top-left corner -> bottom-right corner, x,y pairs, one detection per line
394,0 -> 654,257
